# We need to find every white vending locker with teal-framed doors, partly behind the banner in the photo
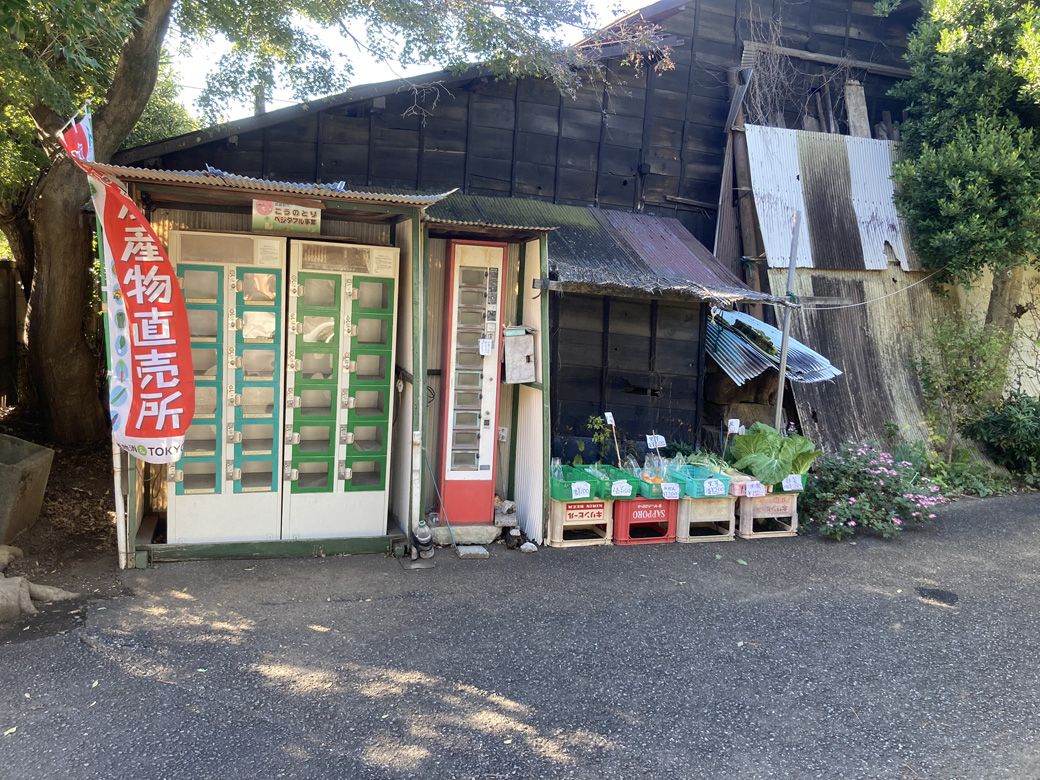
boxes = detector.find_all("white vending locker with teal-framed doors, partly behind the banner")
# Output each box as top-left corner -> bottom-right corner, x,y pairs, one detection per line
166,231 -> 285,544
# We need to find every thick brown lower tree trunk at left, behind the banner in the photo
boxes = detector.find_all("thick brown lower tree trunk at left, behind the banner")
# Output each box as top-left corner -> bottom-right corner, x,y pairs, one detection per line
27,160 -> 107,443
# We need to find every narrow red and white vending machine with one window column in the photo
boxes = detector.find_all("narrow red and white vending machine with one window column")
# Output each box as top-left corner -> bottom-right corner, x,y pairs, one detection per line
440,241 -> 505,525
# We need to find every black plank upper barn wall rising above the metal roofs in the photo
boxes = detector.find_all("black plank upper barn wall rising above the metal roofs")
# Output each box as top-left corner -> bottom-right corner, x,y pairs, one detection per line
146,0 -> 908,245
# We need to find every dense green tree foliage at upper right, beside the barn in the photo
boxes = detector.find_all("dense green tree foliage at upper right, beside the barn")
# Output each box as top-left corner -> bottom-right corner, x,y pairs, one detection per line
893,0 -> 1040,291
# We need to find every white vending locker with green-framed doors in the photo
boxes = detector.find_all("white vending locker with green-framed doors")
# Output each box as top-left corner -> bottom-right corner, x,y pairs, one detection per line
282,240 -> 399,539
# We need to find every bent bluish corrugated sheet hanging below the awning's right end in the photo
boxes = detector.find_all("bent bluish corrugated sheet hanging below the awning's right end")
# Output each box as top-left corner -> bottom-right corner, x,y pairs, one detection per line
705,310 -> 841,385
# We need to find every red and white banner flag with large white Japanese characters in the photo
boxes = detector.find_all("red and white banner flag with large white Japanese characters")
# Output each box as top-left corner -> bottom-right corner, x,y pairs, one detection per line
59,110 -> 194,463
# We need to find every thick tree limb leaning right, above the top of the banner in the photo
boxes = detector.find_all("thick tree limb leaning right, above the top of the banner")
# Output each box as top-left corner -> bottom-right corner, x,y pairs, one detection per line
94,0 -> 174,162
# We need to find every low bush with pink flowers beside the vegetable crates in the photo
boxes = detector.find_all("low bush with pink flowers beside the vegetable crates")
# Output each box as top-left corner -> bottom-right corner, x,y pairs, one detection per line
799,443 -> 947,539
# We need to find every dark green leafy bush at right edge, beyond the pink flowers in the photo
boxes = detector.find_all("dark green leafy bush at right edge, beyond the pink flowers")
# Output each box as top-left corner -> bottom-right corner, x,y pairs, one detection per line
965,391 -> 1040,484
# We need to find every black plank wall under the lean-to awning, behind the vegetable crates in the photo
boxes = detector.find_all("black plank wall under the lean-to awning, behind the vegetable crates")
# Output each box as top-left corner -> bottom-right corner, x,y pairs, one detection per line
550,293 -> 701,461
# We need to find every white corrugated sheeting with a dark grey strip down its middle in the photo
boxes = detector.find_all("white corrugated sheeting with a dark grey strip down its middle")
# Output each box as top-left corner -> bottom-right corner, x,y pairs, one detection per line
745,125 -> 919,270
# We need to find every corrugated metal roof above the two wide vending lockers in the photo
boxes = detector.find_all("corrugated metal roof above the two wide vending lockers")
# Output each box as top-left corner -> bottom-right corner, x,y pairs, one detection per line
85,162 -> 454,206
